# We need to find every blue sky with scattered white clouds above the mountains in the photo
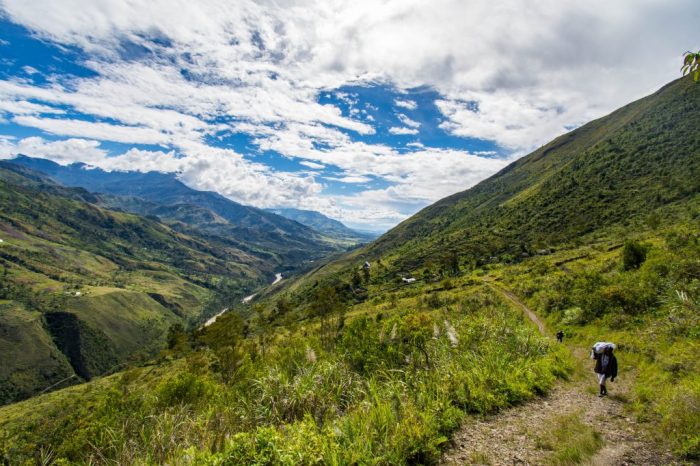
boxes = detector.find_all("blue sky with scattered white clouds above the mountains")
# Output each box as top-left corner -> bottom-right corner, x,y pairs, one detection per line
0,0 -> 700,231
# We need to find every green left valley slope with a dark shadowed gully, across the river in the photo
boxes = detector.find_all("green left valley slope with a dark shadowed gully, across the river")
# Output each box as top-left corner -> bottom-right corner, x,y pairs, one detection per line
0,167 -> 267,403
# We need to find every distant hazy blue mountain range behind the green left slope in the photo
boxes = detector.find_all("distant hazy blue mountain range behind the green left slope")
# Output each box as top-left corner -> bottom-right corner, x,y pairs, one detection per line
11,156 -> 342,269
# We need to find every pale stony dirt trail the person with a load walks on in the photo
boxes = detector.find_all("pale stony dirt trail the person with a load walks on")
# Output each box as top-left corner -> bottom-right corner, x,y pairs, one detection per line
441,281 -> 682,466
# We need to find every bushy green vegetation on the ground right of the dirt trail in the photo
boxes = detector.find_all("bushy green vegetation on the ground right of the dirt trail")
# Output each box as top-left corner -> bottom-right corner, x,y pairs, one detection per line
502,224 -> 700,459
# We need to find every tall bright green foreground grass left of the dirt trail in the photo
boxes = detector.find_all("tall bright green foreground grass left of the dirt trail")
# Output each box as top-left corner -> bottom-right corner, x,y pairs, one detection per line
0,286 -> 568,464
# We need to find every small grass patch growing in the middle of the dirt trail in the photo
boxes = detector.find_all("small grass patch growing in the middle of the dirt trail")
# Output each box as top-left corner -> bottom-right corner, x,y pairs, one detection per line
538,412 -> 603,466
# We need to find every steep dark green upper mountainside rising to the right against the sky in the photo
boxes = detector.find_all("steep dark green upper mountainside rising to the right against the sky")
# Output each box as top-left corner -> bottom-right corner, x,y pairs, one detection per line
365,79 -> 700,267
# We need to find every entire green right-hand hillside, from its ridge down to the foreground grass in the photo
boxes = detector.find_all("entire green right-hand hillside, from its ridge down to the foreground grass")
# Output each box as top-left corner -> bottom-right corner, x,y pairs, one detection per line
0,79 -> 700,465
